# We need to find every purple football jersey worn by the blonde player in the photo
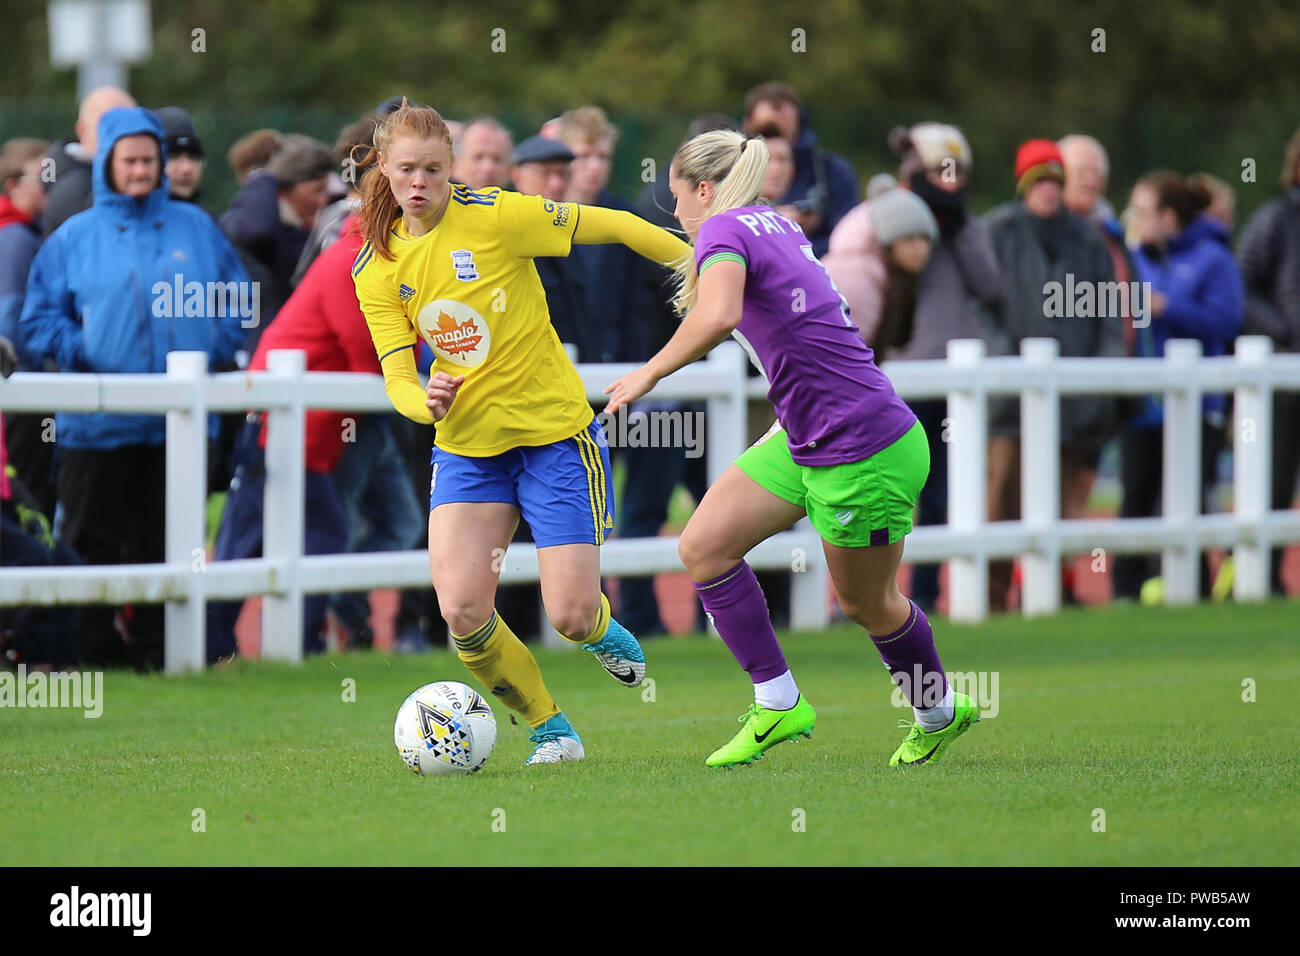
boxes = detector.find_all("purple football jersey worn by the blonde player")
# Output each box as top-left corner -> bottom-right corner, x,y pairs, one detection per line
696,206 -> 917,464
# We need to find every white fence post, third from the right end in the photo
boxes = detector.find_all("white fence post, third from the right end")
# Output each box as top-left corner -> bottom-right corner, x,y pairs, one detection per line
1021,338 -> 1061,617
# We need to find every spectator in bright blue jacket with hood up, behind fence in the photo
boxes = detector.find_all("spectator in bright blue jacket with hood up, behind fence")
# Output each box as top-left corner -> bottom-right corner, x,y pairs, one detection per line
18,107 -> 248,669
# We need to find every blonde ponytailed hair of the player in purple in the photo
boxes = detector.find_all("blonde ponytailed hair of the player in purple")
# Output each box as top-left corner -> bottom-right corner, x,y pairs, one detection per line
672,130 -> 768,315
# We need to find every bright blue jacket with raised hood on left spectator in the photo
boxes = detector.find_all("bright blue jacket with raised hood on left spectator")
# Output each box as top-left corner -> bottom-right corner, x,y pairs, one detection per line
18,107 -> 248,449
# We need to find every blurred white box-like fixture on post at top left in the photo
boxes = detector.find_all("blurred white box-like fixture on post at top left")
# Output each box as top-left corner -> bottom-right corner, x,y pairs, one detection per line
48,0 -> 152,100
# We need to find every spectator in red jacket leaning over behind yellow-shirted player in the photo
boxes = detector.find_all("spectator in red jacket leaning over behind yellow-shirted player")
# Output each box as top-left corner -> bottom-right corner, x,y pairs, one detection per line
208,216 -> 380,662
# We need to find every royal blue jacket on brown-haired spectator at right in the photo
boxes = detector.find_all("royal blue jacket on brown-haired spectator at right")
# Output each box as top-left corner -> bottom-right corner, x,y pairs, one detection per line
1132,216 -> 1245,428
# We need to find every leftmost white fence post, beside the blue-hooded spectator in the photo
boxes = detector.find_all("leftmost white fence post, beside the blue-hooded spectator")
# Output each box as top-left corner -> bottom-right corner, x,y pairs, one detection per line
163,351 -> 208,674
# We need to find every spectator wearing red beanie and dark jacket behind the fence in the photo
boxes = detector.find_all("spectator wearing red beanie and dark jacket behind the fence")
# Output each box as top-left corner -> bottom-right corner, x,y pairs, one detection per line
983,139 -> 1125,611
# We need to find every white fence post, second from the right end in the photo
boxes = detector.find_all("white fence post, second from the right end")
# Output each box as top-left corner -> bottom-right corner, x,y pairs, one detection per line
1161,338 -> 1204,605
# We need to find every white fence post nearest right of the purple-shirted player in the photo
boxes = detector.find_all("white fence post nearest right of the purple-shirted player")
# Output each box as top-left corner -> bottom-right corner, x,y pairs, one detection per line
948,338 -> 988,620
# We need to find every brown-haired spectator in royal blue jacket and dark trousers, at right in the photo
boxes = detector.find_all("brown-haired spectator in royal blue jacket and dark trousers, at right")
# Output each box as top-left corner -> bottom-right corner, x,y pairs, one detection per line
1114,170 -> 1245,598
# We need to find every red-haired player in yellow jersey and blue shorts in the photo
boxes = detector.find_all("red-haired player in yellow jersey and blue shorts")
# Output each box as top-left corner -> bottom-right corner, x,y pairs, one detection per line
352,101 -> 690,763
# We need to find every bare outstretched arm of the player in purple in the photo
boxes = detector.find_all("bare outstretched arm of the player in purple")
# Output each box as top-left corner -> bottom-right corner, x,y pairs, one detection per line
605,260 -> 745,415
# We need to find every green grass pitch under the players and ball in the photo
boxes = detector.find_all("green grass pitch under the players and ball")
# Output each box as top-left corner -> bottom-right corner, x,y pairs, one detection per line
0,601 -> 1300,866
